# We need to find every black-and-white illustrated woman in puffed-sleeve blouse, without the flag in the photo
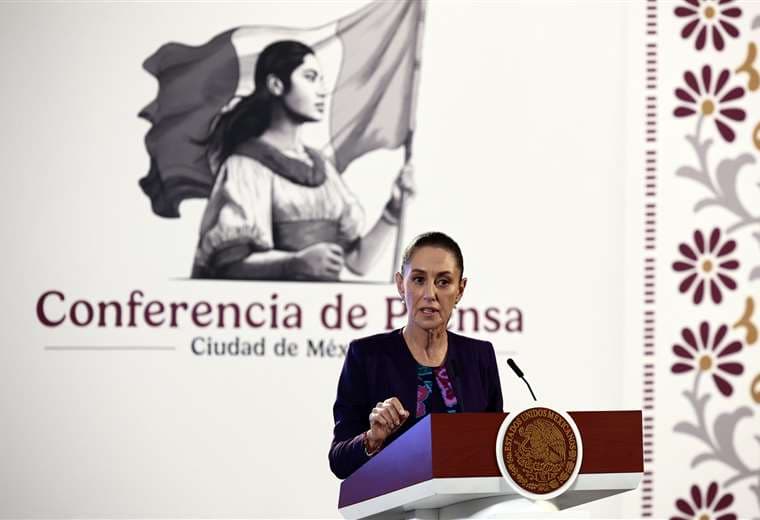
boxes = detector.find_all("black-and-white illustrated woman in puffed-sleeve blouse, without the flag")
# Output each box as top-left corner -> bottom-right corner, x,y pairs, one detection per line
192,41 -> 413,280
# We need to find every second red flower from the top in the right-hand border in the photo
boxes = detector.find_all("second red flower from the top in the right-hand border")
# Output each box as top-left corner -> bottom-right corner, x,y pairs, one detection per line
673,65 -> 747,142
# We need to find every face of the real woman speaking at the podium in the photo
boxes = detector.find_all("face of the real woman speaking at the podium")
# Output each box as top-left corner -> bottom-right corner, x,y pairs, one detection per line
396,246 -> 467,330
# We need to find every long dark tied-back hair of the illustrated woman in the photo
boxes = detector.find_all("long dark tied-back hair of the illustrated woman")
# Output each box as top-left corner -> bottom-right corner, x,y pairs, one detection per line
202,40 -> 314,164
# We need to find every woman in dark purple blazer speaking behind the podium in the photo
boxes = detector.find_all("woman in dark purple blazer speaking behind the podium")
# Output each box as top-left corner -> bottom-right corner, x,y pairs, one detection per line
329,232 -> 503,478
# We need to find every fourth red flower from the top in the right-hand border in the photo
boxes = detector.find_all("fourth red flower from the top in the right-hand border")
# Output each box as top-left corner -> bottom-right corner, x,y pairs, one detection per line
670,321 -> 744,396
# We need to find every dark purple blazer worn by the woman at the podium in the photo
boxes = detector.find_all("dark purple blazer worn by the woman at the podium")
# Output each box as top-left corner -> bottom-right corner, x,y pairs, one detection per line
329,330 -> 503,478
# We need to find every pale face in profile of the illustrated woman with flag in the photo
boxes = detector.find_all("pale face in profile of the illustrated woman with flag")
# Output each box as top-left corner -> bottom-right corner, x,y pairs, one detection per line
282,54 -> 327,121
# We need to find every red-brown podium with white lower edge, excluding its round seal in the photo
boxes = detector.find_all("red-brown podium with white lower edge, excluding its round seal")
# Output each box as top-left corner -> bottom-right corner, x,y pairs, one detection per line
338,411 -> 644,520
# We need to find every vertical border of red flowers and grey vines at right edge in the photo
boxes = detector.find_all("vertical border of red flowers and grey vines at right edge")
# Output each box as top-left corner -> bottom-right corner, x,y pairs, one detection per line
670,0 -> 760,520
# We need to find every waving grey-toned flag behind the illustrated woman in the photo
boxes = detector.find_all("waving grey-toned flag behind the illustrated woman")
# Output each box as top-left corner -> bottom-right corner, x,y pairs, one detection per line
140,0 -> 423,217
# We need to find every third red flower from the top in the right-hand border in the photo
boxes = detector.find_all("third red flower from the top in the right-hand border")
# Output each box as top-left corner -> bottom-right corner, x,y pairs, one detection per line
673,228 -> 739,304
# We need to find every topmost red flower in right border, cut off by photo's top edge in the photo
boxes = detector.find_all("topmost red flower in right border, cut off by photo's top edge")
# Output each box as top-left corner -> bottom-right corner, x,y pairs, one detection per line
674,0 -> 742,51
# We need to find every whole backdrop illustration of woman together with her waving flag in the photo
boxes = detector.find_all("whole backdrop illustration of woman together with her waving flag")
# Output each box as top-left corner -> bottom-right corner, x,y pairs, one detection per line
140,0 -> 425,281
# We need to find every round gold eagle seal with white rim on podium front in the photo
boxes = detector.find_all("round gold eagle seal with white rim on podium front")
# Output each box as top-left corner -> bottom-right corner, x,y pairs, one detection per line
496,407 -> 582,500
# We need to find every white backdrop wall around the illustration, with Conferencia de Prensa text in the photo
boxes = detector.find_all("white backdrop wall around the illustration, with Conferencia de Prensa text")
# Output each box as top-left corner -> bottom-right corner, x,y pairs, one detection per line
0,1 -> 732,518
